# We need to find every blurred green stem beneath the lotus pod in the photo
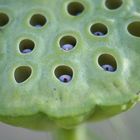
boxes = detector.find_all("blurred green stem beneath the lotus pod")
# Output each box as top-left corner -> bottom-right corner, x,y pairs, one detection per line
53,125 -> 89,140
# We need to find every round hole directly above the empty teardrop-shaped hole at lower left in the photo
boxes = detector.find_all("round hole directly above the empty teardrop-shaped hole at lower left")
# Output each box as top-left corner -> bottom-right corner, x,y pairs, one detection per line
19,39 -> 35,54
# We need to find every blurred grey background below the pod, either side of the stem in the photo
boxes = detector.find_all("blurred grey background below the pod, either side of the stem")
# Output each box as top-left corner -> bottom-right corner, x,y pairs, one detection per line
0,104 -> 140,140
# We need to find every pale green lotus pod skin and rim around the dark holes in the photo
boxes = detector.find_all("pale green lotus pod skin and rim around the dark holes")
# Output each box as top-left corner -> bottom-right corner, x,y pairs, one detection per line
0,0 -> 140,130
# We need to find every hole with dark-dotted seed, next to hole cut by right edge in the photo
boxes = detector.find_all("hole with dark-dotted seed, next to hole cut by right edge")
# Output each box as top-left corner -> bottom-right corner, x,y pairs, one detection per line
90,23 -> 108,36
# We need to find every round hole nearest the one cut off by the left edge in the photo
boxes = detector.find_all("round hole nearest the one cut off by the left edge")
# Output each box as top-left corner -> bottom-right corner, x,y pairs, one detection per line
30,14 -> 47,28
